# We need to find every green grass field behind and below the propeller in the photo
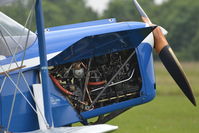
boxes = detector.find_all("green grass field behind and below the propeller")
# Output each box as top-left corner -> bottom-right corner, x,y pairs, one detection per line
109,62 -> 199,133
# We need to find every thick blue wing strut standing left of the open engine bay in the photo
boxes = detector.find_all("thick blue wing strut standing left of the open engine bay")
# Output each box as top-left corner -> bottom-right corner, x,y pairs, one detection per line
35,0 -> 52,127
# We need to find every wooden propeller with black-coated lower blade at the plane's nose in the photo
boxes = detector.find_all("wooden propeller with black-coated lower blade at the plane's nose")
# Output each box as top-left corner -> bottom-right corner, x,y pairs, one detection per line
133,0 -> 196,106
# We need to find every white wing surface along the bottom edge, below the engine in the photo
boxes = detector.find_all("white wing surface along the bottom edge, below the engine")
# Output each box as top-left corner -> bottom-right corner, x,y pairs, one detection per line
21,124 -> 118,133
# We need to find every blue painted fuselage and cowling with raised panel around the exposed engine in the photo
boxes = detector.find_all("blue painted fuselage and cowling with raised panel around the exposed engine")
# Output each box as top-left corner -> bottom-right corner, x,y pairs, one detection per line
0,20 -> 155,132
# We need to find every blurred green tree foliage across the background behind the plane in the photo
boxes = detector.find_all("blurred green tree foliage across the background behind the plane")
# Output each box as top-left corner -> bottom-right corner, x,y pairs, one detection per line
0,0 -> 199,61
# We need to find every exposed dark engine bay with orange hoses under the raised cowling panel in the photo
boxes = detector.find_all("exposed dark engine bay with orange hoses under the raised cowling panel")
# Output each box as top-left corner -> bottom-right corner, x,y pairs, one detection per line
49,49 -> 142,112
